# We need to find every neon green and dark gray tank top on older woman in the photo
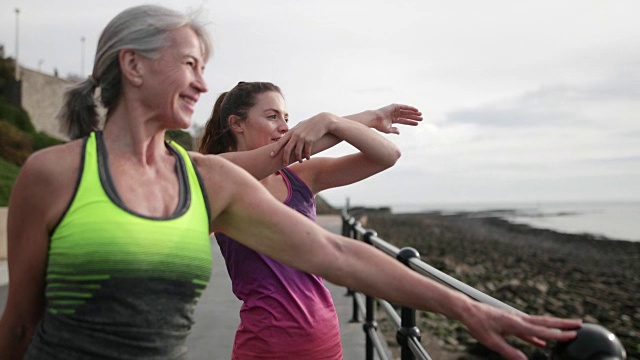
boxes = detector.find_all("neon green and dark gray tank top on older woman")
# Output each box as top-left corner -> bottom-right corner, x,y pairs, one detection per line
26,132 -> 211,359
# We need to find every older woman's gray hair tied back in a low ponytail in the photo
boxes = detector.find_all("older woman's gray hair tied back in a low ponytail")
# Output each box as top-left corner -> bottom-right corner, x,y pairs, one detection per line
58,5 -> 212,139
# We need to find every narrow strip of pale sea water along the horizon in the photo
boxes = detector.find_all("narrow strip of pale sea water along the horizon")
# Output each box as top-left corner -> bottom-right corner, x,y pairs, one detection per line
391,202 -> 640,241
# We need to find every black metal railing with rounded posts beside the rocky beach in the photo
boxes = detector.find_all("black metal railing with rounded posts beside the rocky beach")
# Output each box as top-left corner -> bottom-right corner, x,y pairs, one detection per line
341,204 -> 627,360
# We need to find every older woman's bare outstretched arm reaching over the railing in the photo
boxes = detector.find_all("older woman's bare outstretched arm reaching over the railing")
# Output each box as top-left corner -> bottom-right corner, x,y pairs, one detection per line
194,157 -> 581,360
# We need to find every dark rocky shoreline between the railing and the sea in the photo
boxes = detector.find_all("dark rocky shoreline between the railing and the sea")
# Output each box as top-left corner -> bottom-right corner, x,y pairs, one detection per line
361,212 -> 640,360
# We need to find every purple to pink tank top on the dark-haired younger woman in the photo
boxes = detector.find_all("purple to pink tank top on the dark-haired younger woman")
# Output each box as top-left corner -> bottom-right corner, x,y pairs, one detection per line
215,168 -> 342,360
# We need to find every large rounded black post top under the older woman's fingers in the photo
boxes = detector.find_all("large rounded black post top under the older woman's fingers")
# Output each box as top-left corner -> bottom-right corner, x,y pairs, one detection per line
550,323 -> 627,360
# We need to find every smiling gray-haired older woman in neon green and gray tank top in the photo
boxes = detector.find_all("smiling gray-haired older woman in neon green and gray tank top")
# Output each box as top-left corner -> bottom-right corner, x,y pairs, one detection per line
0,5 -> 580,360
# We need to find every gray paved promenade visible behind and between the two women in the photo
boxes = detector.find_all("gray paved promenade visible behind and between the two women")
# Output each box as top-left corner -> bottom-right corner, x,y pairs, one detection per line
0,215 -> 365,360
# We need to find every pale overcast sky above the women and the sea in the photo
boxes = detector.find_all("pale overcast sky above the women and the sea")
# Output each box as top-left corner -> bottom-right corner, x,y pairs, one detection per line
0,0 -> 640,205
